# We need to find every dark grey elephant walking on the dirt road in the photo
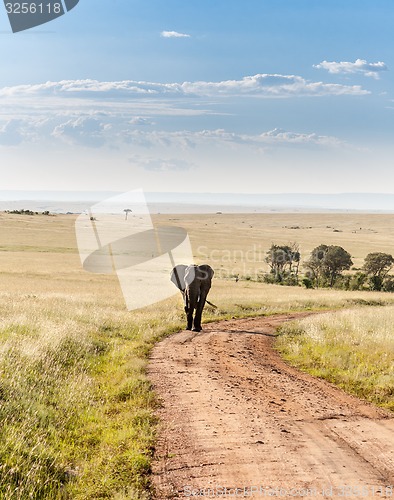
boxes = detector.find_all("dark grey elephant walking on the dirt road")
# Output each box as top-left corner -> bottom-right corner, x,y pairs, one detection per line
171,264 -> 214,332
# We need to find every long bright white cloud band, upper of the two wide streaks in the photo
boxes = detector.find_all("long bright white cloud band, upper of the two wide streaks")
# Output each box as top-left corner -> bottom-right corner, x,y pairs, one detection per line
0,74 -> 370,101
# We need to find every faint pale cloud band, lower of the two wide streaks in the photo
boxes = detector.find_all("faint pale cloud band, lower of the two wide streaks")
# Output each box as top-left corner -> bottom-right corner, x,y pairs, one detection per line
0,114 -> 346,151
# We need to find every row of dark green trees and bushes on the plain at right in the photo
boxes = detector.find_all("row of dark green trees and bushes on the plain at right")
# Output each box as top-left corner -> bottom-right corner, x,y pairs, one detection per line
261,243 -> 394,292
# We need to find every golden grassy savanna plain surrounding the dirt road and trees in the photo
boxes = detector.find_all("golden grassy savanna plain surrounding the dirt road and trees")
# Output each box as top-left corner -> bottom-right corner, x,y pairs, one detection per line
0,209 -> 394,499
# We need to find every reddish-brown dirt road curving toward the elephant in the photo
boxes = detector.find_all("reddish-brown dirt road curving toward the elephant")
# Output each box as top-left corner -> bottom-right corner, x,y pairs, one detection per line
149,314 -> 394,500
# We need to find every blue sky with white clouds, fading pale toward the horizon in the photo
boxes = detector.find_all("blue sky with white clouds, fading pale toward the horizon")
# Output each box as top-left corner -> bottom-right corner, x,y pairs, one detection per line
0,0 -> 394,193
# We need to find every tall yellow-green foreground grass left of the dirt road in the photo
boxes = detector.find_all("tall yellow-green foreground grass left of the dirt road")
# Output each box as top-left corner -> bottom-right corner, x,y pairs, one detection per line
0,293 -> 188,500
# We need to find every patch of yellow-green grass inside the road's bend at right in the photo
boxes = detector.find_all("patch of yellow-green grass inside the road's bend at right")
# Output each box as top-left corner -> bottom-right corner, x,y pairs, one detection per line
277,306 -> 394,411
